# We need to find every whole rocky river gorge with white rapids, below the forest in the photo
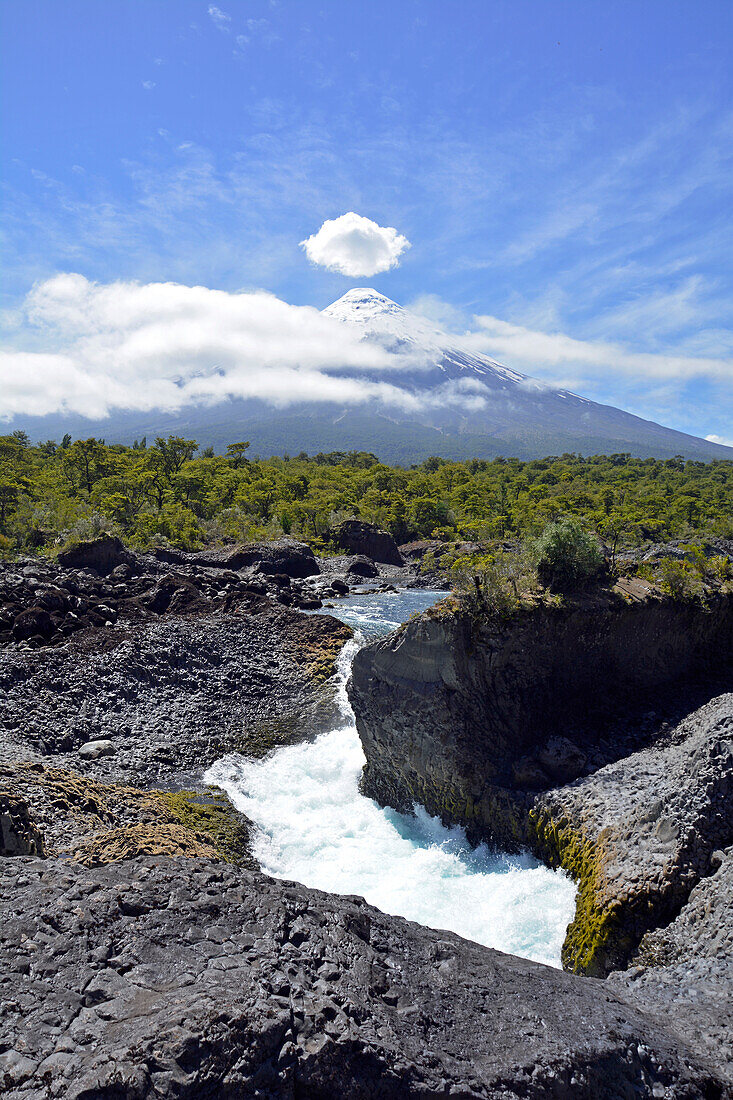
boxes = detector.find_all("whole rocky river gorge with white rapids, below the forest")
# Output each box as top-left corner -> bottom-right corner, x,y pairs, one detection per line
0,538 -> 733,1100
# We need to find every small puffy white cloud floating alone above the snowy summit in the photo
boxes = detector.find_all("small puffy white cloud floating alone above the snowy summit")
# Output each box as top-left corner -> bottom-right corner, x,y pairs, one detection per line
300,211 -> 409,278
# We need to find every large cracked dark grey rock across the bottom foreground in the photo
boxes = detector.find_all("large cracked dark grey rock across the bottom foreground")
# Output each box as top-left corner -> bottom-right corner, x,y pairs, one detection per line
0,859 -> 733,1100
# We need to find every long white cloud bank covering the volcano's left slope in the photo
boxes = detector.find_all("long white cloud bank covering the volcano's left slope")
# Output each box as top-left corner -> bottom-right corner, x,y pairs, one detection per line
0,274 -> 471,418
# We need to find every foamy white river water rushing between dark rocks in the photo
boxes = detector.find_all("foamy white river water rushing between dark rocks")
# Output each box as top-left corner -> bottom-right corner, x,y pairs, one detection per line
206,592 -> 576,966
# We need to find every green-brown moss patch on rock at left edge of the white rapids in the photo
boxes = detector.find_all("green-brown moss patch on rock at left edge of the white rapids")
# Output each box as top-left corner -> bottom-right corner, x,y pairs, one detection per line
155,788 -> 256,867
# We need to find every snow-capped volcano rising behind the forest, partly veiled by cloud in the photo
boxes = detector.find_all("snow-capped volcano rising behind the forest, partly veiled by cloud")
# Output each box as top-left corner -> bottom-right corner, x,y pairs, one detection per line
7,287 -> 731,464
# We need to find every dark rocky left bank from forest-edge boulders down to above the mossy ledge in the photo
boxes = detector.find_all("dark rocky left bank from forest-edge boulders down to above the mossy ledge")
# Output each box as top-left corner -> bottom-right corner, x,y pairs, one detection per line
0,538 -> 431,787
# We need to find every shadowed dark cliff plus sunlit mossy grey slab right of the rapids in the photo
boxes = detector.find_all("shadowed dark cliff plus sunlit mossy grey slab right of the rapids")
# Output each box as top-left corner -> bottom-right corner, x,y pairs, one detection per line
349,584 -> 733,992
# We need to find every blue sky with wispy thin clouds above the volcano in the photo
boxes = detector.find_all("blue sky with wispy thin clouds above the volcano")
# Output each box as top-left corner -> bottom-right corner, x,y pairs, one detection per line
0,0 -> 733,440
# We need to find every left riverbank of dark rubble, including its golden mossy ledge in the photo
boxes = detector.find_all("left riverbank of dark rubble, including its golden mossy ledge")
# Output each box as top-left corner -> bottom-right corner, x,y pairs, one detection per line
0,538 -> 363,865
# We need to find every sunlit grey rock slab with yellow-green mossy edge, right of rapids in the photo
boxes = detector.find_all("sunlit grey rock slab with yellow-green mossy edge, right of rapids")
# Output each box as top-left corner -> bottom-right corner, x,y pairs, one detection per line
529,694 -> 733,976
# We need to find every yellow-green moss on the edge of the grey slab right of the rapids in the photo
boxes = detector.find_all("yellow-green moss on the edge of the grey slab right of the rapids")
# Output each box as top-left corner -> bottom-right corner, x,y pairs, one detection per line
528,810 -> 619,976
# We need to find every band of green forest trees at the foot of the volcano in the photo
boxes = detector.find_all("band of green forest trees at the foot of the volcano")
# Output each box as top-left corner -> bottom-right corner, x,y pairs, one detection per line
0,431 -> 733,554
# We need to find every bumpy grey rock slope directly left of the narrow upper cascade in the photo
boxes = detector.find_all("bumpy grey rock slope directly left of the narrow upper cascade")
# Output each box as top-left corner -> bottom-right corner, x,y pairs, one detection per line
0,596 -> 351,785
